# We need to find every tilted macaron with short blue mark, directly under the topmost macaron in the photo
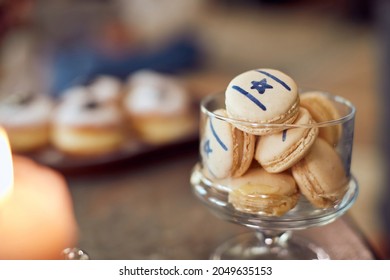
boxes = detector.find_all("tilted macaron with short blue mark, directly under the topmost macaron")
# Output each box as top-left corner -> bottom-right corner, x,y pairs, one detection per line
254,108 -> 318,173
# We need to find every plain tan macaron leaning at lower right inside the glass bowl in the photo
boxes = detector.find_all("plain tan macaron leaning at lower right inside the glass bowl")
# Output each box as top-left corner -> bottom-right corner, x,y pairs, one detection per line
291,137 -> 348,208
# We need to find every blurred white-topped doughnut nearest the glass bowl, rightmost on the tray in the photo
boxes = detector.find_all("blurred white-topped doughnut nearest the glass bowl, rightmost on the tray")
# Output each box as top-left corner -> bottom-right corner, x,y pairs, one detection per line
123,70 -> 196,144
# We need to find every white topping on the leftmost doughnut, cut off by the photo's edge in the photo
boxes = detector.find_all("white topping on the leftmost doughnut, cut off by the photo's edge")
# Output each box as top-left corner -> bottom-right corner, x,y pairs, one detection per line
0,94 -> 53,127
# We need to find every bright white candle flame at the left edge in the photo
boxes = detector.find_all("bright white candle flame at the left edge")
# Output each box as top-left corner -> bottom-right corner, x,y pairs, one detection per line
0,127 -> 14,202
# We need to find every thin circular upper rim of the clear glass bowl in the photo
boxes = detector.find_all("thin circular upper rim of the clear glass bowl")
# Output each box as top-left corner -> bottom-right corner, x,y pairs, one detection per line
200,90 -> 356,129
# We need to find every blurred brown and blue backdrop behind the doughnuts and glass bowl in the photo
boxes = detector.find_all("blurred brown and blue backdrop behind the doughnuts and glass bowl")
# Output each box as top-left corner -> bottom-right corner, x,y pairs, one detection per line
0,0 -> 390,258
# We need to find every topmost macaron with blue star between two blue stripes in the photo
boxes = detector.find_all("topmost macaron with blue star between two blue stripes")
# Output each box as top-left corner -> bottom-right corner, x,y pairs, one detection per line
225,69 -> 299,135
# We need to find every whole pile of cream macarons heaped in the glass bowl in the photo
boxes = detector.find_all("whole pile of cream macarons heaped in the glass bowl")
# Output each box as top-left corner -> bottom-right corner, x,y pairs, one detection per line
201,69 -> 348,216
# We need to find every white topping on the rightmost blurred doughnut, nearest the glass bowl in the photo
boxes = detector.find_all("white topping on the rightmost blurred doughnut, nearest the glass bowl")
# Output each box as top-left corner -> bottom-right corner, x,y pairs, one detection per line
124,70 -> 189,115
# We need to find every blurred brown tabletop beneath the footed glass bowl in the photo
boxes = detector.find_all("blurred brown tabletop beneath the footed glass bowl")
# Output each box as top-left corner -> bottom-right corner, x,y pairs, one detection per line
67,142 -> 375,260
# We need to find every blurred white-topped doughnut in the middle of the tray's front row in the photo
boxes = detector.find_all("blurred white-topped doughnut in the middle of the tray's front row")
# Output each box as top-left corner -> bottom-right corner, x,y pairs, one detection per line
51,87 -> 125,156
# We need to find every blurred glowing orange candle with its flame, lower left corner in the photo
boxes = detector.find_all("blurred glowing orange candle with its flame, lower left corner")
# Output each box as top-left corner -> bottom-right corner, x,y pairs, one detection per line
0,127 -> 77,260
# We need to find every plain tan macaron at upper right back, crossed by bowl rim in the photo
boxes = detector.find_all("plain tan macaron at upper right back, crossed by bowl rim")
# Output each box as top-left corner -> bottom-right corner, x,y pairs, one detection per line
300,91 -> 342,145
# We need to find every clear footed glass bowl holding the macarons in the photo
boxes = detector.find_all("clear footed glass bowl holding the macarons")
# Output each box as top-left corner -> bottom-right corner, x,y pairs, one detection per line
190,93 -> 359,260
